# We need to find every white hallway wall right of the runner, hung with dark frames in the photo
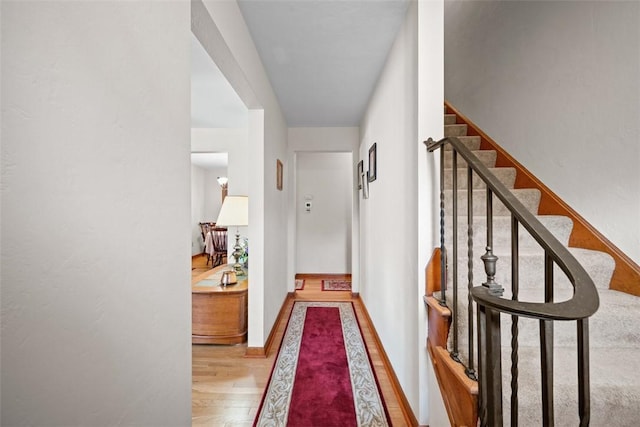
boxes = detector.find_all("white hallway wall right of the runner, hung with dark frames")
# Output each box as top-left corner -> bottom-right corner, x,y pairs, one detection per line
360,2 -> 423,420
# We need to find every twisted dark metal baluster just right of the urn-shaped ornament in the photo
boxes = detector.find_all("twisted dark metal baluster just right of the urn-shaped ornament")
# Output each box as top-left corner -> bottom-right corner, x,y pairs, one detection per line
511,215 -> 520,427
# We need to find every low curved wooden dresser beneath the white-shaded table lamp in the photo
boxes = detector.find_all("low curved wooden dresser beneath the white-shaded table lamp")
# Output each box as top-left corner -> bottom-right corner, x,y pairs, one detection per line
191,265 -> 249,344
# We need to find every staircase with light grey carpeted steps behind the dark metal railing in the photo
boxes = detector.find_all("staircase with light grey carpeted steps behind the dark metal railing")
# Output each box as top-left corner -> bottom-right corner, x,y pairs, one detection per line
430,104 -> 640,426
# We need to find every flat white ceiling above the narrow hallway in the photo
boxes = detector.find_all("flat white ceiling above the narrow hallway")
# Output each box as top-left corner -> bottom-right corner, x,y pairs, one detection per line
238,0 -> 409,127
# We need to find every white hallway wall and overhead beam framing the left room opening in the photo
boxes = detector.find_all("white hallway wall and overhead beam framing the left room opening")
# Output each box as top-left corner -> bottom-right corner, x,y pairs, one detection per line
191,0 -> 290,347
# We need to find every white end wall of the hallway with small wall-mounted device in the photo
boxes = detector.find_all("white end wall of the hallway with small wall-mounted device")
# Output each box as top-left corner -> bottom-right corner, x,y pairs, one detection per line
296,153 -> 353,274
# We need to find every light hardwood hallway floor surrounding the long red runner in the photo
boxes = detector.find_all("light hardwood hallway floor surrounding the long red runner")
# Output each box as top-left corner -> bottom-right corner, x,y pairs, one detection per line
192,274 -> 413,427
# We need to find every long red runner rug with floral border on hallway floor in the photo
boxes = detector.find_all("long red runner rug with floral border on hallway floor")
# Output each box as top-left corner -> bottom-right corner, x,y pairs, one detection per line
254,301 -> 390,427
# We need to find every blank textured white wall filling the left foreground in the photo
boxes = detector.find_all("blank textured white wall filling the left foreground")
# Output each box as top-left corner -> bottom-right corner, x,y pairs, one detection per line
1,1 -> 191,426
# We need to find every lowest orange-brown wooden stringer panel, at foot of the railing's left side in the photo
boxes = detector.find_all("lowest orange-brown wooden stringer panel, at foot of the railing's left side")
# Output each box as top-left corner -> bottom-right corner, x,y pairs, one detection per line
427,339 -> 478,427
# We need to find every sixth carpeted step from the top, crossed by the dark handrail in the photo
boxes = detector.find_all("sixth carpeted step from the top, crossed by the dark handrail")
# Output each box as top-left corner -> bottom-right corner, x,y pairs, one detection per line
444,188 -> 540,216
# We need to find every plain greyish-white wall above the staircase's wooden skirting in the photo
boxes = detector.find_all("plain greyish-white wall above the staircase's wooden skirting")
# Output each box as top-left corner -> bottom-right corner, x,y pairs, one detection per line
445,1 -> 640,262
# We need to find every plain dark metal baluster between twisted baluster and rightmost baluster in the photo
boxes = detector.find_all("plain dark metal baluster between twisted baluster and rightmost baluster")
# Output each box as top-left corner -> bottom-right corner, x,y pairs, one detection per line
540,251 -> 554,427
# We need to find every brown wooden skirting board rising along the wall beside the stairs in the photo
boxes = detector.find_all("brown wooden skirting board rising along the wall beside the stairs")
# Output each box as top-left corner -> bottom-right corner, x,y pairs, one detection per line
445,101 -> 640,296
